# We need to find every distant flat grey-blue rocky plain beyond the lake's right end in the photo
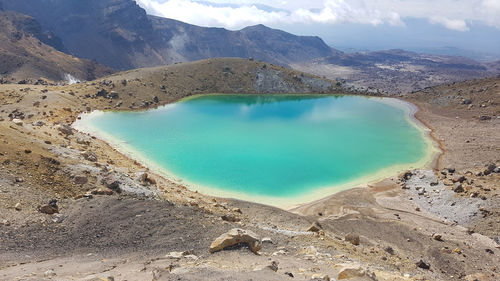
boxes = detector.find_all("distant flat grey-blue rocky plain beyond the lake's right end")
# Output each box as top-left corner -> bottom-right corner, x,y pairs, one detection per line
292,50 -> 500,95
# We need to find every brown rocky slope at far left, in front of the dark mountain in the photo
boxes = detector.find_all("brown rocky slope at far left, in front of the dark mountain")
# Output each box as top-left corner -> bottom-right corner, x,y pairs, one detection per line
0,11 -> 112,84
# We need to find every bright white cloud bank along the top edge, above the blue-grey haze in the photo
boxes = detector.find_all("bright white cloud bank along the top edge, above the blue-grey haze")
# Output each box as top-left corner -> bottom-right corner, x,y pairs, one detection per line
137,0 -> 500,31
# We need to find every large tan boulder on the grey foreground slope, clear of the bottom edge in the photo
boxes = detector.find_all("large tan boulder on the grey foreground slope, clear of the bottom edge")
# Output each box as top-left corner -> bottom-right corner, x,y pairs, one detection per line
210,228 -> 262,253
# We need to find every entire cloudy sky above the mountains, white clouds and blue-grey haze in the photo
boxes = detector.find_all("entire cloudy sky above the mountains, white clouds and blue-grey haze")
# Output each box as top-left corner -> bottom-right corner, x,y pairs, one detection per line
136,0 -> 500,59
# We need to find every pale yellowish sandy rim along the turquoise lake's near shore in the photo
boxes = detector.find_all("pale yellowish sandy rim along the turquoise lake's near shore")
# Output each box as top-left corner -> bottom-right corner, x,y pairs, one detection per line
73,94 -> 441,210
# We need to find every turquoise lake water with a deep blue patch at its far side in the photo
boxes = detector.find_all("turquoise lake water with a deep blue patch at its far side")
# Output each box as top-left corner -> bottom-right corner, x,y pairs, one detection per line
80,95 -> 428,197
